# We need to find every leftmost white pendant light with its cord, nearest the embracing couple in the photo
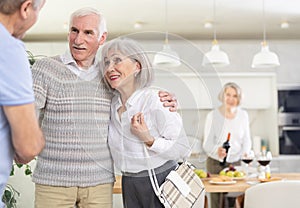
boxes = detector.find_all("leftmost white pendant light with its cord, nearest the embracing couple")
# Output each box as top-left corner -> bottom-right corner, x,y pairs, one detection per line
153,0 -> 181,67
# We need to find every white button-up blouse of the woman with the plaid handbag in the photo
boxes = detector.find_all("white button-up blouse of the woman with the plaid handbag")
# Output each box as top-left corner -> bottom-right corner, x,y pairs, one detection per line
108,89 -> 190,173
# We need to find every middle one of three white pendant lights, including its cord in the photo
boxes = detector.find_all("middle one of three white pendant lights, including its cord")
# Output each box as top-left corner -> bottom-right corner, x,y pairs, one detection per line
202,0 -> 229,67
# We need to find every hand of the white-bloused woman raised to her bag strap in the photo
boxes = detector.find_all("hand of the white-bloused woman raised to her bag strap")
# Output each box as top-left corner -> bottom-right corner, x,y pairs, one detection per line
130,113 -> 154,147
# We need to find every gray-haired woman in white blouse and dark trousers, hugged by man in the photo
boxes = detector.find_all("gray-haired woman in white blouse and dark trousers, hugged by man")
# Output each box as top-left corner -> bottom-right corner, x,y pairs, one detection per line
101,38 -> 190,208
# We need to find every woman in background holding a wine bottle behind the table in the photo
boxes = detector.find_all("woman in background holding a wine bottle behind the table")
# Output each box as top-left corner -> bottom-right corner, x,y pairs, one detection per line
203,82 -> 251,208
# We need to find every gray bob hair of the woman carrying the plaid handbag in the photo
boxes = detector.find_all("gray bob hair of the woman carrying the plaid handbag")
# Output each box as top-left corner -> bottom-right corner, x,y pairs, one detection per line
100,38 -> 154,90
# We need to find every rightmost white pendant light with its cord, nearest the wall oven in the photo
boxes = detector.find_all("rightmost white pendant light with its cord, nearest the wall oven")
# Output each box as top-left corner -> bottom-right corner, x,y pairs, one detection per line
252,0 -> 280,68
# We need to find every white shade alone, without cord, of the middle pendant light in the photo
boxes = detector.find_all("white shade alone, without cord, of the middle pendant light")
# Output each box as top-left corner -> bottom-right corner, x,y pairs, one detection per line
202,43 -> 230,67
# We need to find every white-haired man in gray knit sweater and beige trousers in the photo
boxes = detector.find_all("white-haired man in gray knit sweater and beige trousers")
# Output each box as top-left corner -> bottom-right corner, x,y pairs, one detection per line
32,8 -> 176,208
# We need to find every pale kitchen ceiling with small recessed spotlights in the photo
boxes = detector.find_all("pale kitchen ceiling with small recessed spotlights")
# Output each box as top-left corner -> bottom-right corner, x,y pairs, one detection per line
25,0 -> 300,41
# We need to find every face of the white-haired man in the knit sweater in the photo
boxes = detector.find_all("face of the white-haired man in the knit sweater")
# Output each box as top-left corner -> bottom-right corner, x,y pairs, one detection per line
68,14 -> 106,68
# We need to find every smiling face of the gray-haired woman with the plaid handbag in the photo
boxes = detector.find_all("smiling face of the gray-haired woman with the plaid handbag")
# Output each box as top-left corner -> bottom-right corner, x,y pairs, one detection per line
104,51 -> 140,92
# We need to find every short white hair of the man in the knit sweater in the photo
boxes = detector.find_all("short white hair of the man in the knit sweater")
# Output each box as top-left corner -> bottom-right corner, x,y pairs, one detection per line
70,7 -> 107,40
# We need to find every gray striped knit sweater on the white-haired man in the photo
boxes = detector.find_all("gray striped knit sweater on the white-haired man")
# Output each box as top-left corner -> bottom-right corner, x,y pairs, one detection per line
32,56 -> 114,187
